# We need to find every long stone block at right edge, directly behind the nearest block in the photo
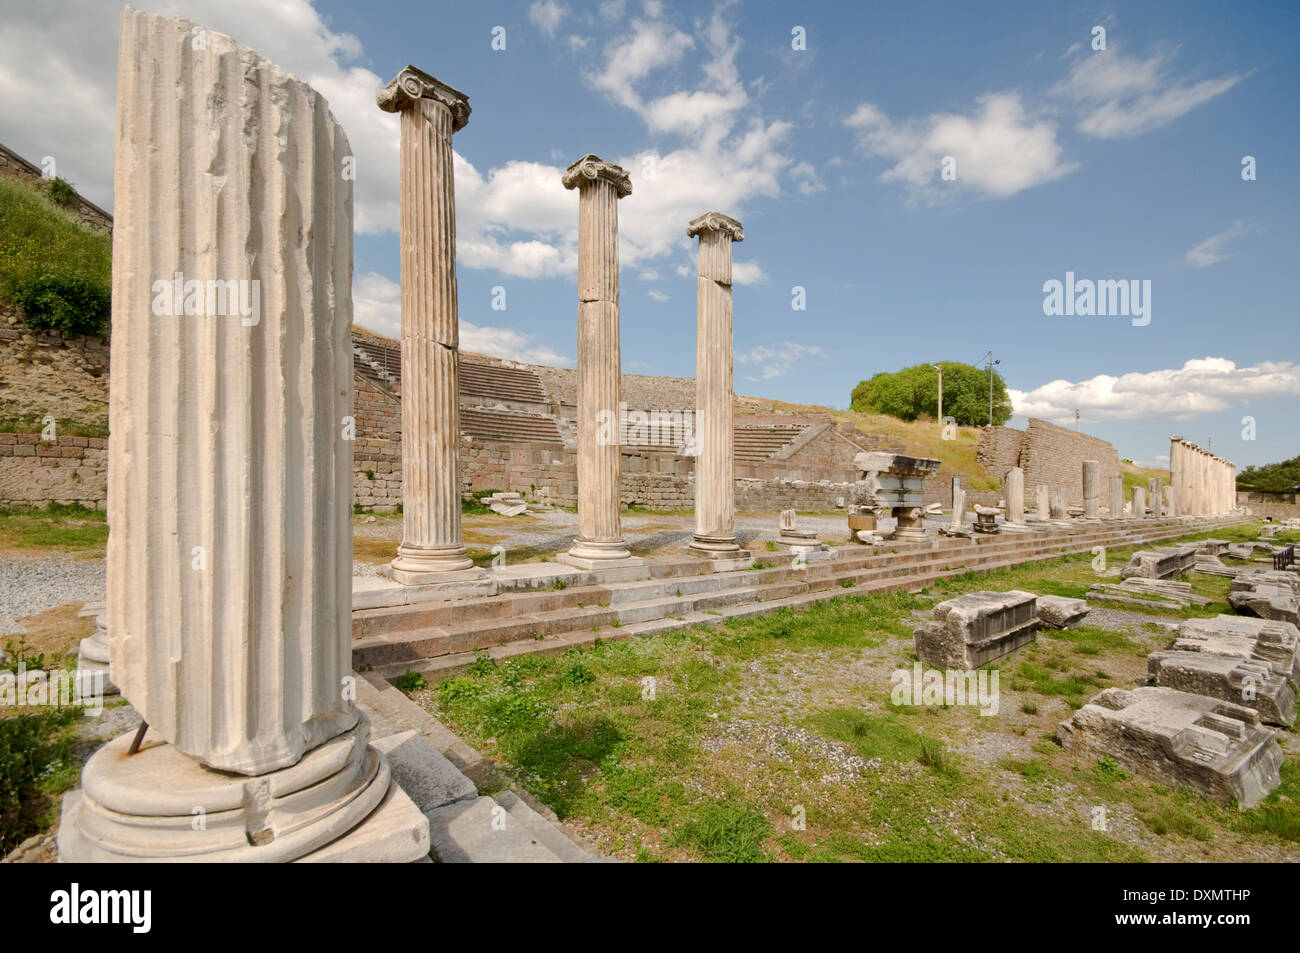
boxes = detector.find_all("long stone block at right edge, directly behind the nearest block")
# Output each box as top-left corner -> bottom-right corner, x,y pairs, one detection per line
1147,651 -> 1296,725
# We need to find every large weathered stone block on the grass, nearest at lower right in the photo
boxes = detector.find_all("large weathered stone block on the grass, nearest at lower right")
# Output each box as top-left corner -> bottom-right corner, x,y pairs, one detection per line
1058,686 -> 1282,809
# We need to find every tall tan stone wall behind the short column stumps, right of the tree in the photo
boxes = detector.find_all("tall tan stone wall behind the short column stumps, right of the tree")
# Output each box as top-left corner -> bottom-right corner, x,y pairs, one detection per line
975,417 -> 1121,506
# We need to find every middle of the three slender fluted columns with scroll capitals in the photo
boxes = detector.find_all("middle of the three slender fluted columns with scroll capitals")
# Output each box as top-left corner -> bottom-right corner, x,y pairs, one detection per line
559,155 -> 641,569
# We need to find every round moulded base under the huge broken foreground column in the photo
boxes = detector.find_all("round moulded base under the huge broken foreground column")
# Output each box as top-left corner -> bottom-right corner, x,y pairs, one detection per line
57,712 -> 429,863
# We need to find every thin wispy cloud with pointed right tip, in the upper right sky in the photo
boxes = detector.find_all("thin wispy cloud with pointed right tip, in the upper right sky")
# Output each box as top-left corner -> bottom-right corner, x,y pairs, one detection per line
1052,47 -> 1242,139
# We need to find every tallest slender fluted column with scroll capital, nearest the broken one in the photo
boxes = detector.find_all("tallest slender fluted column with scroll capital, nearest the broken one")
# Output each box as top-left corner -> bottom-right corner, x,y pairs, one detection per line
377,66 -> 482,585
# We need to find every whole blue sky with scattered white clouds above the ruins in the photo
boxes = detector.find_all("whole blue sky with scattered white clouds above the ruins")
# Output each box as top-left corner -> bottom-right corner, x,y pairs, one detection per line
0,0 -> 1300,465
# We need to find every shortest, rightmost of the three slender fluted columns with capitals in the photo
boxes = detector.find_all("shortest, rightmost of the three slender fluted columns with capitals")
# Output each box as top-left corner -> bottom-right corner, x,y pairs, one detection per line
686,212 -> 749,558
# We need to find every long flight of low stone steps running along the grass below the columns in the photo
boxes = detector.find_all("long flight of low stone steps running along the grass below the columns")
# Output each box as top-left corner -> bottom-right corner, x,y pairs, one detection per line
352,517 -> 1242,680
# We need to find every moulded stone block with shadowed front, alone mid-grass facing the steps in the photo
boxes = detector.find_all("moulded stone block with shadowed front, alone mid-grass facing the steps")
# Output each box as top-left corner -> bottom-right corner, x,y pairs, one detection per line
914,589 -> 1039,670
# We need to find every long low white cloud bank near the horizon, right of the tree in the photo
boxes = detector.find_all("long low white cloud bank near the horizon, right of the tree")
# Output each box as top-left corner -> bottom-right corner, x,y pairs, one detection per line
1009,358 -> 1300,420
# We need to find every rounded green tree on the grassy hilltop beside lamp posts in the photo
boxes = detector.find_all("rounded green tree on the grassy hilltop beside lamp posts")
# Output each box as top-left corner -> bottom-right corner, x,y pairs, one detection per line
849,360 -> 1011,426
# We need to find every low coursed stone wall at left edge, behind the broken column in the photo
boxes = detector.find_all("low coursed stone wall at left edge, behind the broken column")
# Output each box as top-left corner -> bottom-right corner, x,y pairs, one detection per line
0,433 -> 108,510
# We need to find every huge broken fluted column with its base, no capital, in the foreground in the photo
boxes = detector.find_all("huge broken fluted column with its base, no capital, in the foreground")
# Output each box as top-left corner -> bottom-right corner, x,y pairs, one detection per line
59,8 -> 428,862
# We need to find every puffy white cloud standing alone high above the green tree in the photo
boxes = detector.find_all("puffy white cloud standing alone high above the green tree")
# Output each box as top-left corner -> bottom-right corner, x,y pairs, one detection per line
844,92 -> 1075,198
